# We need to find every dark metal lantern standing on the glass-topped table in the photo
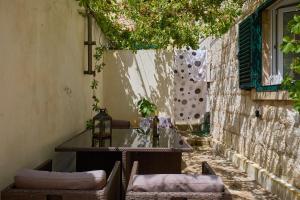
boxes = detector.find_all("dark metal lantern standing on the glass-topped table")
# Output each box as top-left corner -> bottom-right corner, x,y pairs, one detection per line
92,109 -> 112,146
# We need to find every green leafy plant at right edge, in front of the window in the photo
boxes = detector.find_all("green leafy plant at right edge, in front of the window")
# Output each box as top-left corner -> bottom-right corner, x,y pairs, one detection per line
281,5 -> 300,112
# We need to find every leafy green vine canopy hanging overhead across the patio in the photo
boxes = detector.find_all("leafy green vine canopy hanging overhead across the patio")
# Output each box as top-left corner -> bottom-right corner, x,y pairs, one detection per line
76,0 -> 243,50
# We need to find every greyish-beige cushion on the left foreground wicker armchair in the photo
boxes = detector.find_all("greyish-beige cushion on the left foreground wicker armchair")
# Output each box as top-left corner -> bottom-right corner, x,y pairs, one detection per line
15,169 -> 106,190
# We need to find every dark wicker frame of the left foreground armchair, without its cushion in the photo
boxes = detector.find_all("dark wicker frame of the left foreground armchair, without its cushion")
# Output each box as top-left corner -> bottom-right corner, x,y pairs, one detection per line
1,160 -> 121,200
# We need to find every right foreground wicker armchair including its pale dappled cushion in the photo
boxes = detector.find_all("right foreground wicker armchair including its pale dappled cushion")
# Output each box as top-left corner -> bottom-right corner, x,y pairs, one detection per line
126,161 -> 231,200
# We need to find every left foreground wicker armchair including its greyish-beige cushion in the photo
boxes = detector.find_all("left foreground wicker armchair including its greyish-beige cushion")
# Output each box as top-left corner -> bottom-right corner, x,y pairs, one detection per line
1,160 -> 121,200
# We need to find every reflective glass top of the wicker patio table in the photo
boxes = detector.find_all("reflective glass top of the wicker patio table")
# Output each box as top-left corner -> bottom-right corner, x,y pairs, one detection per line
55,128 -> 192,152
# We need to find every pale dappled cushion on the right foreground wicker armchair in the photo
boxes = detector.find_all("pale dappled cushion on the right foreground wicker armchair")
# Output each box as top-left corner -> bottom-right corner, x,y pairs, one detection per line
130,174 -> 224,192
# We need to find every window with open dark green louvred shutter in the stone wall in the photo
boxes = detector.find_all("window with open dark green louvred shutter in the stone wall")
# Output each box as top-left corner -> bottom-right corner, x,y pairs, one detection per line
238,0 -> 300,91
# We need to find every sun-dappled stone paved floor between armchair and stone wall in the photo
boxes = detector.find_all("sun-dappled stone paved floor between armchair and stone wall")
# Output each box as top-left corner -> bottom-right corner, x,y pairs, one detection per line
182,147 -> 279,200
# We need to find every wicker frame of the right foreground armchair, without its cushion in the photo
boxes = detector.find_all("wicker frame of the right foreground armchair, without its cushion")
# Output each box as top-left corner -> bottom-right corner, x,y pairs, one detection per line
126,161 -> 232,200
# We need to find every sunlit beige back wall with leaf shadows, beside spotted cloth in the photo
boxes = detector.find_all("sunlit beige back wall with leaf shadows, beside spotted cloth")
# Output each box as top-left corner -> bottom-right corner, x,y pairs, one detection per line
102,50 -> 174,125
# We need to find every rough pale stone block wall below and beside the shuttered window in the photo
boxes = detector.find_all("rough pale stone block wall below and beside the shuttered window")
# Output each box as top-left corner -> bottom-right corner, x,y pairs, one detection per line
201,1 -> 300,198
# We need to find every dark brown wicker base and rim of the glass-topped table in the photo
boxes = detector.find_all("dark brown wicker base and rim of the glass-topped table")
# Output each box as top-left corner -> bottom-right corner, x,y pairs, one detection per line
55,129 -> 193,198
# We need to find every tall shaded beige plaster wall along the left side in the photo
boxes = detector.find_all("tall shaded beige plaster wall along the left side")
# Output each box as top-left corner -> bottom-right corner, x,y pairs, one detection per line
0,0 -> 102,189
